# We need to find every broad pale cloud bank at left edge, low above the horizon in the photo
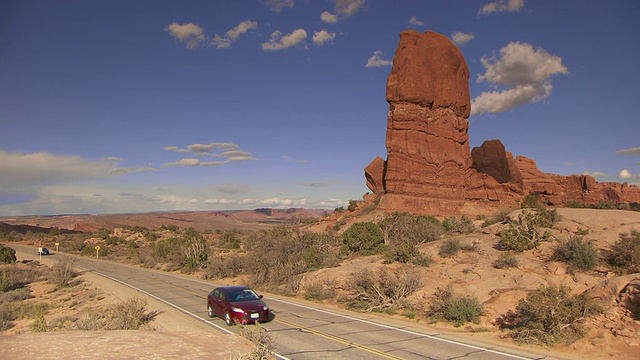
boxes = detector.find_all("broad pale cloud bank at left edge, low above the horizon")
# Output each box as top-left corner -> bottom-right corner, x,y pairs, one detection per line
0,151 -> 156,194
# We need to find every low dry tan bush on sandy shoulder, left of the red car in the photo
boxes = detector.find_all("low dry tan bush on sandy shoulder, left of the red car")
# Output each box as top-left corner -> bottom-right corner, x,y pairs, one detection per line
106,298 -> 162,330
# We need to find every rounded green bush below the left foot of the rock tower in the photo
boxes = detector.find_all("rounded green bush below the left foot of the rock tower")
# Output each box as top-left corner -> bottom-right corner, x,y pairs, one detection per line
342,222 -> 386,255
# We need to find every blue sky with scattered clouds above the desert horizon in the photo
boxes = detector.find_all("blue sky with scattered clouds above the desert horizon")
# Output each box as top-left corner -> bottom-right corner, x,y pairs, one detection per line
0,0 -> 640,216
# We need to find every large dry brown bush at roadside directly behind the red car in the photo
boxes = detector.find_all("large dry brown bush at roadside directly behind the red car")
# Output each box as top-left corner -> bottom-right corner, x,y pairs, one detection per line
245,226 -> 306,289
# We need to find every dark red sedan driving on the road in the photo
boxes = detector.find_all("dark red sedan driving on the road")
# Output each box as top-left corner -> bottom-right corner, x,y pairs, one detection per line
207,286 -> 271,326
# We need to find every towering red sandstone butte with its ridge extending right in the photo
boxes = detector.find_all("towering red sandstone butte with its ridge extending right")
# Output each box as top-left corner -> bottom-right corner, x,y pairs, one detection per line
364,30 -> 640,216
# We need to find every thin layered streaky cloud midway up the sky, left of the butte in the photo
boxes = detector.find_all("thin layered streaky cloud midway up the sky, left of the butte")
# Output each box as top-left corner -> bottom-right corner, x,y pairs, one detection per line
162,142 -> 256,167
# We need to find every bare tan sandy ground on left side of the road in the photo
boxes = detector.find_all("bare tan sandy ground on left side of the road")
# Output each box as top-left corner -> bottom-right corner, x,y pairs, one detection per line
0,248 -> 255,359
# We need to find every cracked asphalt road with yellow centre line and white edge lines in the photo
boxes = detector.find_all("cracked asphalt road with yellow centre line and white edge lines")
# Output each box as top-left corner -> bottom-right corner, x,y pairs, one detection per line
9,244 -> 551,360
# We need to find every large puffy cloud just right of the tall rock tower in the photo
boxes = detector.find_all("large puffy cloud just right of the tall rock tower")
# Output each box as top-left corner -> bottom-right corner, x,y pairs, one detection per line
471,42 -> 568,114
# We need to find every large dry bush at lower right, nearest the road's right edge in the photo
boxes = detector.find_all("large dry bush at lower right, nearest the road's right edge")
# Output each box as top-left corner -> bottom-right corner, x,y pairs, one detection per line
496,286 -> 601,345
